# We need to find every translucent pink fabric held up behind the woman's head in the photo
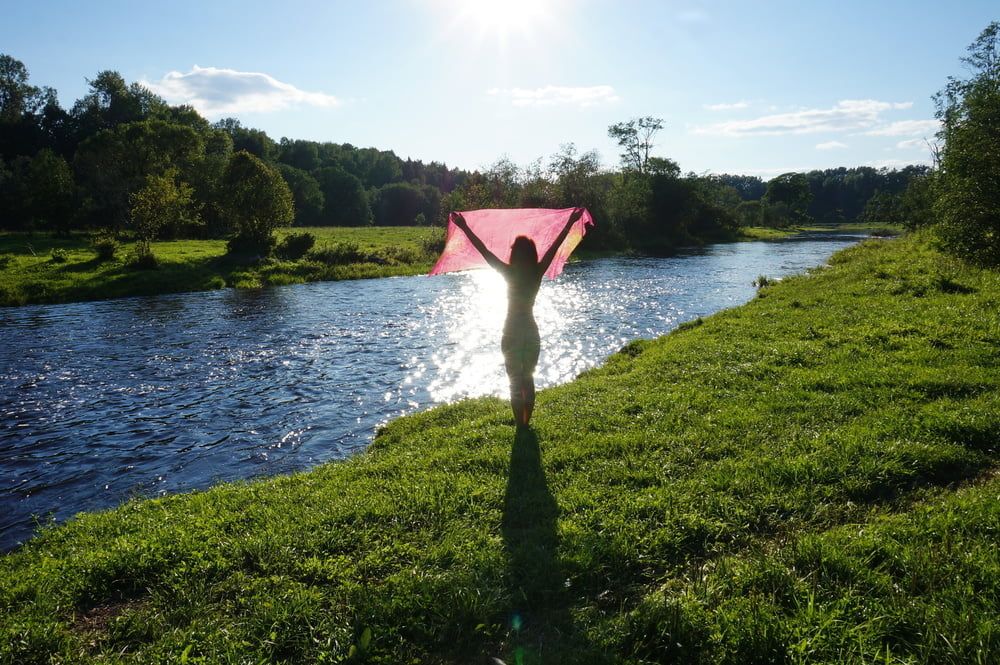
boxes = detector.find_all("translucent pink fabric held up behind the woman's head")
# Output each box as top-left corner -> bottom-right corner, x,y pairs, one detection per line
430,208 -> 594,279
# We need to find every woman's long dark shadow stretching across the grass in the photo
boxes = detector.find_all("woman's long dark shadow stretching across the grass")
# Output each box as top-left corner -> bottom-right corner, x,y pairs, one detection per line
502,428 -> 606,665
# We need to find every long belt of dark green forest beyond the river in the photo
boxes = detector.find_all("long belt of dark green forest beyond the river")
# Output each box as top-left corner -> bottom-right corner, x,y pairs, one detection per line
0,55 -> 928,253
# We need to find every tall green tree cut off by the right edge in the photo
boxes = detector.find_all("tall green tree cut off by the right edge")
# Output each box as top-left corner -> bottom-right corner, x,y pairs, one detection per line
934,22 -> 1000,266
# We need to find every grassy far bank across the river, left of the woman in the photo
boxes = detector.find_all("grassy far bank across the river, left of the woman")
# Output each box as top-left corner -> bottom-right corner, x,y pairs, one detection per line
0,227 -> 442,305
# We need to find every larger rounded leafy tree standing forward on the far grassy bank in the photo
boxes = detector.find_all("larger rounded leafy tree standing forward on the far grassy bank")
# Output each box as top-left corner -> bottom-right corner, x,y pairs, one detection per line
223,150 -> 295,255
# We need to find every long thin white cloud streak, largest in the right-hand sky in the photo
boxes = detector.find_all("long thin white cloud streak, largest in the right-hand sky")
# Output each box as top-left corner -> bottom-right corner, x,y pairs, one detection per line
694,99 -> 913,136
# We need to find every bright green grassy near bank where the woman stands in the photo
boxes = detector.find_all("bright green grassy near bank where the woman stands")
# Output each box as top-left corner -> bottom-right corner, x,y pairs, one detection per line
0,237 -> 1000,663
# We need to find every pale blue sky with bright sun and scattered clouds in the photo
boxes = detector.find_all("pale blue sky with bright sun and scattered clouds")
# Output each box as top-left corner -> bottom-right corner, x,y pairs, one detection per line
0,0 -> 1000,177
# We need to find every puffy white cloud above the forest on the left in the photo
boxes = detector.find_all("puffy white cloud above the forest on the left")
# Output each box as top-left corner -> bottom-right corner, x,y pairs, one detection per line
142,65 -> 340,116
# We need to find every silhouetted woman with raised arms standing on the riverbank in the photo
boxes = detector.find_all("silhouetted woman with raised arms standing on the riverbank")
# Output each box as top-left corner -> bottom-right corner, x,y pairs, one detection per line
454,208 -> 583,427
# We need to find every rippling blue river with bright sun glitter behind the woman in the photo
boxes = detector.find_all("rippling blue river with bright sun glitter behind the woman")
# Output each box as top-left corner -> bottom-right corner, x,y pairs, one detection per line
0,236 -> 858,549
